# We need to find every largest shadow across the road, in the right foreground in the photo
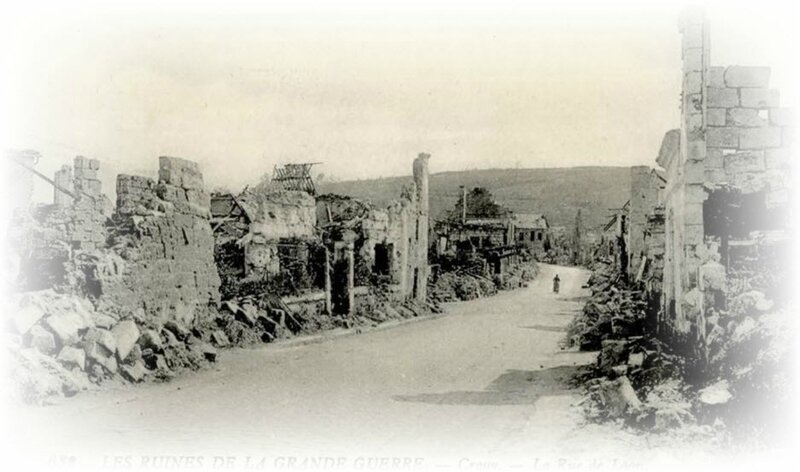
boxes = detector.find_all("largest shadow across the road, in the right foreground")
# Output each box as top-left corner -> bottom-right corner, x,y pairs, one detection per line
393,366 -> 588,405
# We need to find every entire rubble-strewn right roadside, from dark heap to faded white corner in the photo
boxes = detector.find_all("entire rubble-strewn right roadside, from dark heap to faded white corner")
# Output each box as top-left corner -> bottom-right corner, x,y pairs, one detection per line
564,247 -> 792,444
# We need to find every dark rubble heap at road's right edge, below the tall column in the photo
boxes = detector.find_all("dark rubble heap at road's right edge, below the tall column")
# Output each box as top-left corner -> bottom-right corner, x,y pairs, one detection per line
564,263 -> 708,432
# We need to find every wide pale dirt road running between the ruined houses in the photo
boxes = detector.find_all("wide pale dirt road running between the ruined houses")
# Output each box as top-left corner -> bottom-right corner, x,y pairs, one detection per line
6,266 -> 724,470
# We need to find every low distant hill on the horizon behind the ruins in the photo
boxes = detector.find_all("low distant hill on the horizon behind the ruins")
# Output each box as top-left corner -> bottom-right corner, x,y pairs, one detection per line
319,166 -> 631,229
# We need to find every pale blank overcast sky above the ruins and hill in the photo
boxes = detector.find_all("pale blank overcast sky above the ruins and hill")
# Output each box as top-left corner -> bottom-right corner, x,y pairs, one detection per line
0,2 -> 797,201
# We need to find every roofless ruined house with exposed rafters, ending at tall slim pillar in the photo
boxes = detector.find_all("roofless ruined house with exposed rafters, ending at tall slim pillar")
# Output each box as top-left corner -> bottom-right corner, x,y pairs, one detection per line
212,154 -> 430,314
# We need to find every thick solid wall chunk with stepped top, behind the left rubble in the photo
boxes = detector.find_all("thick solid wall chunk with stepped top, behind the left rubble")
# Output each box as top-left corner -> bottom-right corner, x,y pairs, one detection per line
101,157 -> 220,325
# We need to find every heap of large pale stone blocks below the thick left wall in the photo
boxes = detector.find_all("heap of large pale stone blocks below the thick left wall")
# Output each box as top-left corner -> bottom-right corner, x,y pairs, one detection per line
6,290 -> 220,403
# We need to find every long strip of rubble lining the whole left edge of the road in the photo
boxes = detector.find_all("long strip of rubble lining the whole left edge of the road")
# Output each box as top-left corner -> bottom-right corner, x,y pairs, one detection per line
5,284 -> 440,404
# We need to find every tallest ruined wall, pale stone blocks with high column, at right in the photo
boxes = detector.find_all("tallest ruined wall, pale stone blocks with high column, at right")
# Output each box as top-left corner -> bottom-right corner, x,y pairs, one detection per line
658,10 -> 793,346
